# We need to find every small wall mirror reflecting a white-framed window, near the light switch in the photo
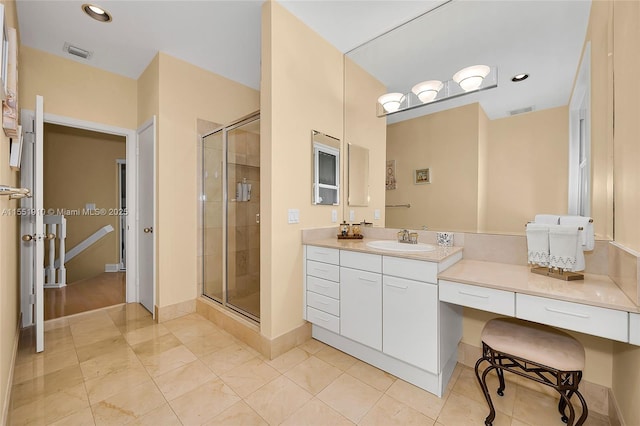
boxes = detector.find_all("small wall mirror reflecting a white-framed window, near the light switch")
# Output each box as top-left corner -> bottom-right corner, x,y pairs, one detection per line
311,130 -> 340,206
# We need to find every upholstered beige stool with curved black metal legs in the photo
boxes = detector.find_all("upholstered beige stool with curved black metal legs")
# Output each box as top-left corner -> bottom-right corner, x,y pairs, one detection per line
476,318 -> 588,426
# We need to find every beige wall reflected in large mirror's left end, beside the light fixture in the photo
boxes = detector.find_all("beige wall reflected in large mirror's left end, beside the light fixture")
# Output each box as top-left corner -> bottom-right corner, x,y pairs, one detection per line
338,56 -> 387,226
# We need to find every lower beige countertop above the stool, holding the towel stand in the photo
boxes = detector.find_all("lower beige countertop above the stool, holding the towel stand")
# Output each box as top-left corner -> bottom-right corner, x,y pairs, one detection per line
438,259 -> 640,312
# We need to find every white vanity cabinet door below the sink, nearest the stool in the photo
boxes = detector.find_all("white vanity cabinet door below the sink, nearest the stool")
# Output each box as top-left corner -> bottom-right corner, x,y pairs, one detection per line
382,275 -> 438,373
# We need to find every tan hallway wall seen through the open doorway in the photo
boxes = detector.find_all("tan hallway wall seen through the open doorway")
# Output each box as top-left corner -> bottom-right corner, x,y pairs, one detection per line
43,124 -> 126,283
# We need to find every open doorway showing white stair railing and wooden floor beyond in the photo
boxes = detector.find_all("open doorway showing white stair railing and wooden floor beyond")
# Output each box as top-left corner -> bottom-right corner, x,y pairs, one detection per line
43,123 -> 126,320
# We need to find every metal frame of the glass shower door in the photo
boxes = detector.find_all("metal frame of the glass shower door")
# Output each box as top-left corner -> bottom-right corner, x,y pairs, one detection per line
200,111 -> 262,323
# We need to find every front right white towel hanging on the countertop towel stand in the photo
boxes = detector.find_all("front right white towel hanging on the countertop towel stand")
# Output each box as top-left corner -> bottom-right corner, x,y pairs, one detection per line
549,225 -> 585,271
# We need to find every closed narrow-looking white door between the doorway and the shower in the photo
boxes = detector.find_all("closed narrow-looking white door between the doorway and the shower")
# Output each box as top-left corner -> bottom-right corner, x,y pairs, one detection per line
136,117 -> 156,317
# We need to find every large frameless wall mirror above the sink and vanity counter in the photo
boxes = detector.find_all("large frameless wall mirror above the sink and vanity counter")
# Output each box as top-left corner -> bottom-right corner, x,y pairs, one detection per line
345,0 -> 613,239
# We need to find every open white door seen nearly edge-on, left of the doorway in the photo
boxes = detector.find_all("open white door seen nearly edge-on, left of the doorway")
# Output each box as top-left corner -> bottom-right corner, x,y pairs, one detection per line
20,96 -> 44,352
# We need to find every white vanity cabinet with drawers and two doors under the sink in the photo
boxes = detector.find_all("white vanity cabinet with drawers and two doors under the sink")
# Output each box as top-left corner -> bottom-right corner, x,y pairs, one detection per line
304,246 -> 462,396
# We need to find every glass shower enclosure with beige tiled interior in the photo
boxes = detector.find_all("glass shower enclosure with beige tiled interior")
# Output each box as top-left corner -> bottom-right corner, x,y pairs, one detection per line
202,113 -> 260,321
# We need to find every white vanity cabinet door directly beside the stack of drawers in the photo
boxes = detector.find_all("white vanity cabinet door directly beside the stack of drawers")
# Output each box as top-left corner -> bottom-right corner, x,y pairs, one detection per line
340,268 -> 382,350
